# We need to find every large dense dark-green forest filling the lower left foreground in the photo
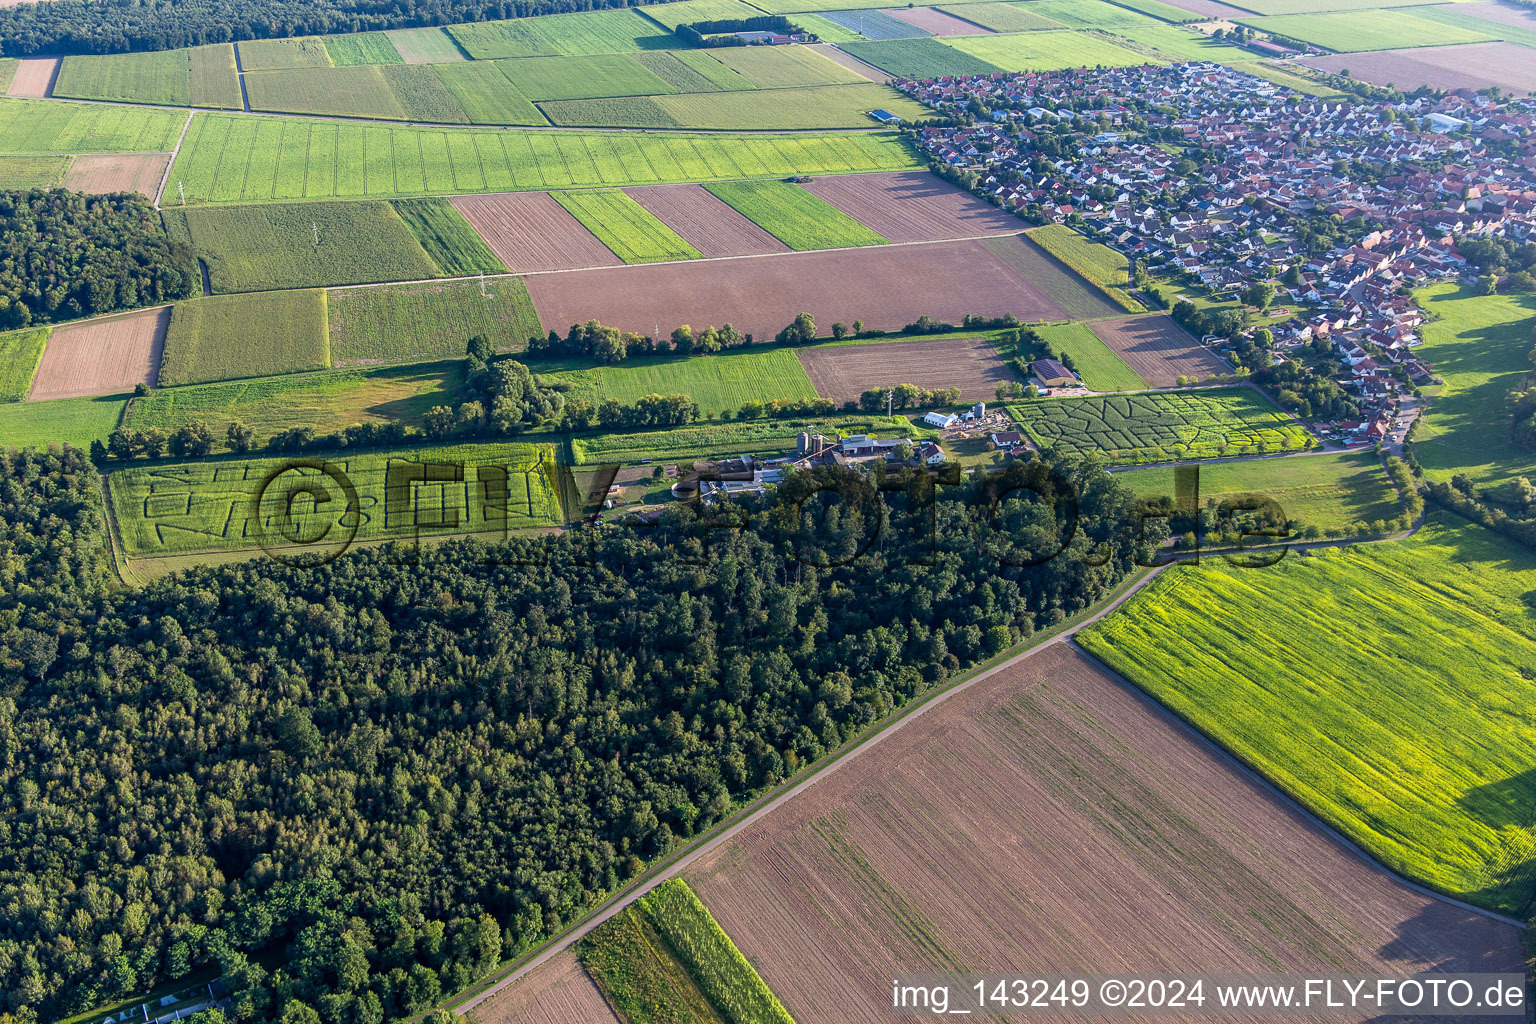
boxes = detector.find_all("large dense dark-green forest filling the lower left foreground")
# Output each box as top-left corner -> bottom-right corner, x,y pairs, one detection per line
0,450 -> 1161,1024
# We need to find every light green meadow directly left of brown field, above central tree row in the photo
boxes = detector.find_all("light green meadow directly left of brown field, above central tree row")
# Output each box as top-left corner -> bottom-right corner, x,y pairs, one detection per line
549,348 -> 816,413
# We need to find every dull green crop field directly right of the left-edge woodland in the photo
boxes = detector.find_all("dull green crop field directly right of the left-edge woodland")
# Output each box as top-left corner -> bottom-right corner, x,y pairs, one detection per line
164,201 -> 441,293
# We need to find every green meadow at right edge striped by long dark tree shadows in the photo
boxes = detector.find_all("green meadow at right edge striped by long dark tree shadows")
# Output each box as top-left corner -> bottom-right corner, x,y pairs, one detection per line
1413,284 -> 1536,485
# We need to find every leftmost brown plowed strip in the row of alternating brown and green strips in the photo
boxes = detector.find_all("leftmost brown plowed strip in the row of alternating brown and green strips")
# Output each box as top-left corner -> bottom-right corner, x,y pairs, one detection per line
453,192 -> 624,273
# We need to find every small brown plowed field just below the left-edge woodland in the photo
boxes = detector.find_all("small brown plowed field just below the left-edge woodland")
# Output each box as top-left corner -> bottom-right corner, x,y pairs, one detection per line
26,306 -> 170,402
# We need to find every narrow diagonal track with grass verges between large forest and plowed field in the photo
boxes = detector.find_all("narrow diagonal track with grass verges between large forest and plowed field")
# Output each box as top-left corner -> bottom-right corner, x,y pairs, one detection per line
445,563 -> 1172,1016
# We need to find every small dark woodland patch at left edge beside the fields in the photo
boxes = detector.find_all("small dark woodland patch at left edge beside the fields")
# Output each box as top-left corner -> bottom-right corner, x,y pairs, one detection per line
0,189 -> 201,323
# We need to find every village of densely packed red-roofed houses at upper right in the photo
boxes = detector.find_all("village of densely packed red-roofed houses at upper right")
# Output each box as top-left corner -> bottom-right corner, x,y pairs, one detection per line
899,63 -> 1536,445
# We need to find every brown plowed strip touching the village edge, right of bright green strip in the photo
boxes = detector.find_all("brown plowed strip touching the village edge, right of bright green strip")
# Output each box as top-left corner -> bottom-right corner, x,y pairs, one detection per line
805,170 -> 1023,241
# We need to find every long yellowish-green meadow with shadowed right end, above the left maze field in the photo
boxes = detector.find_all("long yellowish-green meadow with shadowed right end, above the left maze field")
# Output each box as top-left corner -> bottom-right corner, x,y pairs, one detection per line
123,359 -> 464,444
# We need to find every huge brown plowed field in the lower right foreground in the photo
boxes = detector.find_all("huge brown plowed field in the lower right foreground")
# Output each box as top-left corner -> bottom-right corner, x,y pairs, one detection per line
685,645 -> 1524,1024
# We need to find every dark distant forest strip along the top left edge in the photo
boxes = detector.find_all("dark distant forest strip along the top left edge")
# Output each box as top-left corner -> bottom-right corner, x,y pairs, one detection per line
0,0 -> 654,57
